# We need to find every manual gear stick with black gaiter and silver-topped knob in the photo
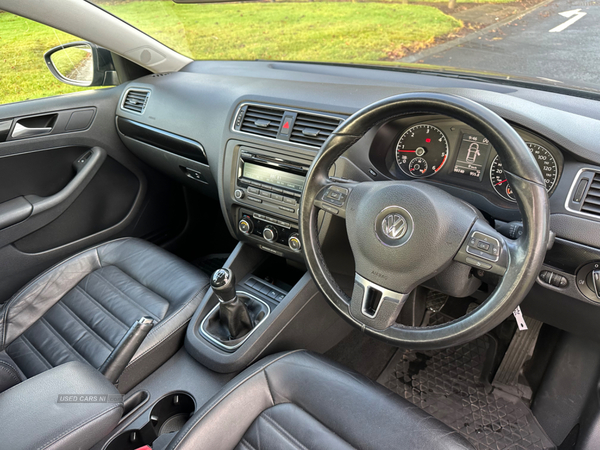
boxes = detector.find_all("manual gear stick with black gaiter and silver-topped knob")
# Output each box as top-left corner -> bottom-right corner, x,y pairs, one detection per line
210,269 -> 252,339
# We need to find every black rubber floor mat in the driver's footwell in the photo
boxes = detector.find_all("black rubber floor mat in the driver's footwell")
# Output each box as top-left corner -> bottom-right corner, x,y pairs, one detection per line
377,314 -> 556,450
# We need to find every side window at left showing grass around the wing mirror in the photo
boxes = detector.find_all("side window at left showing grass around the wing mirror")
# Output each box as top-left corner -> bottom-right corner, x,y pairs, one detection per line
0,11 -> 91,104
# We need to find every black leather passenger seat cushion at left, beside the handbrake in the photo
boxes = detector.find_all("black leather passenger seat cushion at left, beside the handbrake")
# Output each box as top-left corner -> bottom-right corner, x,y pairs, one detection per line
0,238 -> 208,392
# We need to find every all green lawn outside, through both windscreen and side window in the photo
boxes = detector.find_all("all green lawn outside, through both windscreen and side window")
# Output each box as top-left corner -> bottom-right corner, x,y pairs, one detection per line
0,0 -> 462,103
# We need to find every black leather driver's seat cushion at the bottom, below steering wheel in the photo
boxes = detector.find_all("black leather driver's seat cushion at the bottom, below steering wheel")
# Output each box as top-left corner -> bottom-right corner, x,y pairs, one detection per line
168,351 -> 473,450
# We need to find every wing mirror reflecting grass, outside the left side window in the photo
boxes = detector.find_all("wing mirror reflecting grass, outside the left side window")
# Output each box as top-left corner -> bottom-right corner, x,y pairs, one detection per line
44,41 -> 119,87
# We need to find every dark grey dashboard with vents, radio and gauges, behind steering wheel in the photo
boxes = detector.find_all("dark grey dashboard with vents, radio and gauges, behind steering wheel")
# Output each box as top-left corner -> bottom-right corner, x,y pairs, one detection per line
111,62 -> 600,337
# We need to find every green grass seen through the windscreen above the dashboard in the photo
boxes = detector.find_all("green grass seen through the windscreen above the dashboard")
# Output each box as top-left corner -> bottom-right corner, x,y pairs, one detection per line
105,1 -> 461,62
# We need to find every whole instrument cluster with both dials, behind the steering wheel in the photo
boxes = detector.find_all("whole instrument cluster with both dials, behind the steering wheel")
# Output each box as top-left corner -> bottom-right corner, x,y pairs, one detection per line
373,116 -> 563,203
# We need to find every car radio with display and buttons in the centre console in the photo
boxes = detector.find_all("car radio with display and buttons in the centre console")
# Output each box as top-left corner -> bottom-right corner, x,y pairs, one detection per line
234,151 -> 308,220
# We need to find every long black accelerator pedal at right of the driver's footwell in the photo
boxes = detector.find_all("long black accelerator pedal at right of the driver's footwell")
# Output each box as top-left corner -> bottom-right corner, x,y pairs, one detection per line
492,317 -> 542,401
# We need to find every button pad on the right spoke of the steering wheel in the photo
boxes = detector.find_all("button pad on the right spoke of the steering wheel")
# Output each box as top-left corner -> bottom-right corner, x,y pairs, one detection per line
454,219 -> 515,276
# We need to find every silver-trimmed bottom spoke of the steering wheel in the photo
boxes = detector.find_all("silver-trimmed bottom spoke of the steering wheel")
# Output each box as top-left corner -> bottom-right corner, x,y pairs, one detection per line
350,273 -> 410,330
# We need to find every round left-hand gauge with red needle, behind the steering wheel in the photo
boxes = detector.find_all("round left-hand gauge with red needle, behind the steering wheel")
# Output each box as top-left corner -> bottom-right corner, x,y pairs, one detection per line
396,124 -> 448,178
